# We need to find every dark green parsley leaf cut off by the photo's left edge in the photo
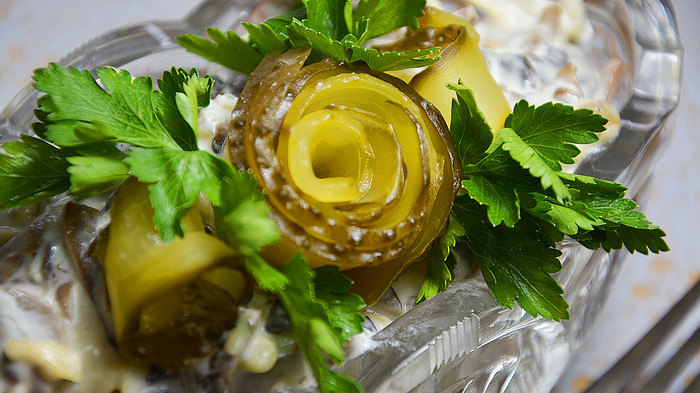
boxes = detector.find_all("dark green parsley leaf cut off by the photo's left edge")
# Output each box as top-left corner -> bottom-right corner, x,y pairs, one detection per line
0,135 -> 70,209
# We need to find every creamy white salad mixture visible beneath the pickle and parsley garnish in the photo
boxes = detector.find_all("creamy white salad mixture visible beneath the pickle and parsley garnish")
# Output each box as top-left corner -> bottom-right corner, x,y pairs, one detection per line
0,0 -> 619,393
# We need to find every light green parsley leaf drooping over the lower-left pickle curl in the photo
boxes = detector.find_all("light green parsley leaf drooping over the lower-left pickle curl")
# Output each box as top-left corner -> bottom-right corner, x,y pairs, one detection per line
125,144 -> 279,248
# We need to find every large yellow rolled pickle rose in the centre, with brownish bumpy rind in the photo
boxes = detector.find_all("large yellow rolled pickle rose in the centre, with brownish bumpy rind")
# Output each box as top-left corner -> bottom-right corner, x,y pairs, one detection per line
228,48 -> 461,300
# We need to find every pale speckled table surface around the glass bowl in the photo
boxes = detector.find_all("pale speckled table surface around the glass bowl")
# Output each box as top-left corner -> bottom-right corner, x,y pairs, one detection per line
0,0 -> 700,392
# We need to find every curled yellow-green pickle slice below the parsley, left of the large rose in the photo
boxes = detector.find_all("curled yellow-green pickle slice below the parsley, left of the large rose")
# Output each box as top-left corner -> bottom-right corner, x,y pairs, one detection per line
104,178 -> 249,364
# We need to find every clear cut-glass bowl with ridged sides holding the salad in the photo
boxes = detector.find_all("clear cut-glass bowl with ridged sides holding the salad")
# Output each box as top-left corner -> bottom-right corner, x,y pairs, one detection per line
0,0 -> 682,393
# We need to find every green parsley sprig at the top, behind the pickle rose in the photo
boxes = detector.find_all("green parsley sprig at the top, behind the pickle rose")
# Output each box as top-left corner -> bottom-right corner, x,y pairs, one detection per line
177,0 -> 439,74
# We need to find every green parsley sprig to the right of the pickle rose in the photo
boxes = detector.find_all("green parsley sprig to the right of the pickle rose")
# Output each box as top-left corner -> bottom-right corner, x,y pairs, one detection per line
419,82 -> 668,321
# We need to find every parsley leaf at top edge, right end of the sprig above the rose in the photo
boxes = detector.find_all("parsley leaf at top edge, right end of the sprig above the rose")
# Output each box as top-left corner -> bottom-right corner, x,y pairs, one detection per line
352,0 -> 425,43
